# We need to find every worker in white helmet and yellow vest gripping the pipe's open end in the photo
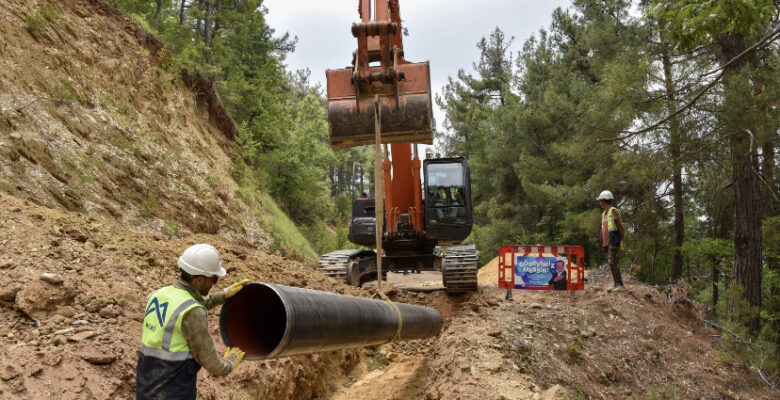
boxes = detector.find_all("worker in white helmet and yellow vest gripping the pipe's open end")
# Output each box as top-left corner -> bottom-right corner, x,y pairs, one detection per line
135,244 -> 249,400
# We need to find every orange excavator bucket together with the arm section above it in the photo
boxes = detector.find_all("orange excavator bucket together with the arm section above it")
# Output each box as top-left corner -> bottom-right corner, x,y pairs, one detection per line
325,0 -> 433,149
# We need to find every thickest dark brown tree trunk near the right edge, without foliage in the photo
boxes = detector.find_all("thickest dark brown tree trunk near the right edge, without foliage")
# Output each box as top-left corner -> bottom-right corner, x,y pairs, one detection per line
718,32 -> 761,333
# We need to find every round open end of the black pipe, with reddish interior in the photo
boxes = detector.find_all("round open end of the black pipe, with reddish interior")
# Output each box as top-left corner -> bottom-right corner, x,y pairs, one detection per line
219,283 -> 288,359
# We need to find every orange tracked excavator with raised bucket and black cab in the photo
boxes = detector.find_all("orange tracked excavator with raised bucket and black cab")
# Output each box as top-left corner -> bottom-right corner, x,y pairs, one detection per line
318,0 -> 478,293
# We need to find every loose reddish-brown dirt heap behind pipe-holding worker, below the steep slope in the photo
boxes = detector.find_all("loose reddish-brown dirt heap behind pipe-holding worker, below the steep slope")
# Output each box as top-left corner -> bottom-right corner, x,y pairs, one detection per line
0,194 -> 367,399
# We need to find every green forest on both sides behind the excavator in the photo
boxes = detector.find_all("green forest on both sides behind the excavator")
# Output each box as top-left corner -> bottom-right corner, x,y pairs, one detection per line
105,0 -> 780,381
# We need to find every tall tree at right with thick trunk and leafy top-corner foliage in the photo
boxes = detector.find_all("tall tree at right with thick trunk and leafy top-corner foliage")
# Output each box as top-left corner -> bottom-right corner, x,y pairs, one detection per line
654,0 -> 776,332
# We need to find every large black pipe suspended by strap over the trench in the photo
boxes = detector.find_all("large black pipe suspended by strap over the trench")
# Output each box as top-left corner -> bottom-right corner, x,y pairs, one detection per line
219,282 -> 442,359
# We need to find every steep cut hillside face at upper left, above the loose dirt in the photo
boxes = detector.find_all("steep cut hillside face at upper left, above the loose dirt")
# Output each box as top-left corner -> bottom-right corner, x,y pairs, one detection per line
0,0 -> 268,247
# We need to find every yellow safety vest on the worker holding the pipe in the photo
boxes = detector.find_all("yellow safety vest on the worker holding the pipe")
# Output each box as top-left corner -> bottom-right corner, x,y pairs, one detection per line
141,286 -> 206,361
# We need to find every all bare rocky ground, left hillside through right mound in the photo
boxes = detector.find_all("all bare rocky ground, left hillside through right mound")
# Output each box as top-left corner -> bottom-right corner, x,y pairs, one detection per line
0,0 -> 778,400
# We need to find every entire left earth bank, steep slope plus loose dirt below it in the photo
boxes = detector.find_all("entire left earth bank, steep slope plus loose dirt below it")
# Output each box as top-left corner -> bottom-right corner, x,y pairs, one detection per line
0,0 -> 365,399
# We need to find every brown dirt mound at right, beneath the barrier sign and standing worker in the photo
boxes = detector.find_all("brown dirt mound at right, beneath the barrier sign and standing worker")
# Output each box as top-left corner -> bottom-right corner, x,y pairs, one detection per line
425,258 -> 777,399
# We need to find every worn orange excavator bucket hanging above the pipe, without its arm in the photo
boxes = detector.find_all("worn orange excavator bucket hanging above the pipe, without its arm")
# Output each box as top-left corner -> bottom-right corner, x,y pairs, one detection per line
326,62 -> 433,149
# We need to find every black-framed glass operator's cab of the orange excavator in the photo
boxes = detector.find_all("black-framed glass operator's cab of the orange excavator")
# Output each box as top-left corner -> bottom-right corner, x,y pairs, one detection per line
423,157 -> 473,246
